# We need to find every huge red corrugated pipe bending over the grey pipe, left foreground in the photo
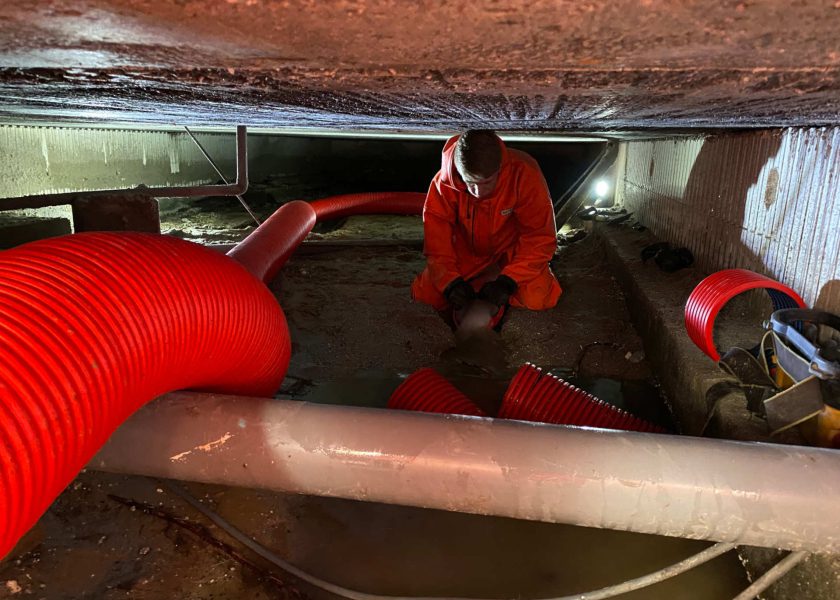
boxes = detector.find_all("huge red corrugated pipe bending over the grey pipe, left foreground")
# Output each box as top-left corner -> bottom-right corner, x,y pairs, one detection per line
0,233 -> 290,558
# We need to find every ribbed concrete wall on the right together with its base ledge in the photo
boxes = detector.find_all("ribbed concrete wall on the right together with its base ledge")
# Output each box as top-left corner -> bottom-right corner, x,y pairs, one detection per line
608,127 -> 840,600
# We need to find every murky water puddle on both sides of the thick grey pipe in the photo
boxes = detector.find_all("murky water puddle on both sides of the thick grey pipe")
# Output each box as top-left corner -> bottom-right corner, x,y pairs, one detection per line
270,365 -> 748,600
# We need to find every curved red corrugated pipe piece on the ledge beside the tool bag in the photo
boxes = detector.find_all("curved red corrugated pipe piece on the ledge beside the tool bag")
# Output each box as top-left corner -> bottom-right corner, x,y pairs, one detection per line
685,269 -> 805,362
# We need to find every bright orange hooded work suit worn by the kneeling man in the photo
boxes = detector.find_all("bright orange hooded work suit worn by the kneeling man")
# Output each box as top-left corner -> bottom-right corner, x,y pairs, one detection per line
411,136 -> 561,310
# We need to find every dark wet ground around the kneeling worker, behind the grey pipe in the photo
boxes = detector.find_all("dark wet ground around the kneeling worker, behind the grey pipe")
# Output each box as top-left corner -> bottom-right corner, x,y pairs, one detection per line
272,217 -> 673,428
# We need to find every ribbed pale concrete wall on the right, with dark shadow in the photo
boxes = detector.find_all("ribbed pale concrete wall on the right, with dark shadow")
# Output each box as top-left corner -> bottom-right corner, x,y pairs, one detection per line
617,127 -> 840,312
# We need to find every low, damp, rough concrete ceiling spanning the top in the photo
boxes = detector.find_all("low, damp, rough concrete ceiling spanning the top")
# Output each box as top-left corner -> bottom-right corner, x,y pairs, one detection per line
0,0 -> 840,133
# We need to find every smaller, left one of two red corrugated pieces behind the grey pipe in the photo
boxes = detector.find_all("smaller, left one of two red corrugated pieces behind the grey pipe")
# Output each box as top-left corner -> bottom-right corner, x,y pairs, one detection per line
388,368 -> 486,417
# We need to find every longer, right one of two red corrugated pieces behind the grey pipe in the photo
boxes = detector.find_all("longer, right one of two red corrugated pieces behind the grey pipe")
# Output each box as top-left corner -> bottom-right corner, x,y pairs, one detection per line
499,363 -> 663,432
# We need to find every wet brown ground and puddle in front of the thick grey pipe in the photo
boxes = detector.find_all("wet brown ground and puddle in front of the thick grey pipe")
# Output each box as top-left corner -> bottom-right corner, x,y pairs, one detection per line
0,473 -> 747,600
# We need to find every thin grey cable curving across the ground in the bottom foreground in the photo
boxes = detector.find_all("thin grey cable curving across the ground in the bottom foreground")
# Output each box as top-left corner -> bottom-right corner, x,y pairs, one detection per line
167,482 -> 740,600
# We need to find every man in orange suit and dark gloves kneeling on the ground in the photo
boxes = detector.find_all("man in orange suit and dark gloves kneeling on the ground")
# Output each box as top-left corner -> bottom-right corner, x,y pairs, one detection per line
411,130 -> 561,321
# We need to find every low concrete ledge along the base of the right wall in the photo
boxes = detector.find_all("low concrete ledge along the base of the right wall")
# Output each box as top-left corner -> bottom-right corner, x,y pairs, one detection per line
595,224 -> 840,600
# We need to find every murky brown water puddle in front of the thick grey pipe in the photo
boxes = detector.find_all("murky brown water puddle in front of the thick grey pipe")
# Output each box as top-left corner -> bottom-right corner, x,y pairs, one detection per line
274,498 -> 749,600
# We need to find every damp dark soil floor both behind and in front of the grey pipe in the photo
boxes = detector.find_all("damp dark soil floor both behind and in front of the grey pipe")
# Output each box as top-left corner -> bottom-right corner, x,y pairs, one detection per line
0,217 -> 747,600
